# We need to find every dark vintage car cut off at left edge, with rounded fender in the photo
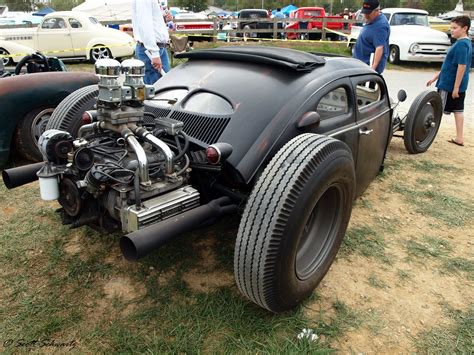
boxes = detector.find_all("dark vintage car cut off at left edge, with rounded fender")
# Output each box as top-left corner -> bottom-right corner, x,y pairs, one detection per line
0,71 -> 98,166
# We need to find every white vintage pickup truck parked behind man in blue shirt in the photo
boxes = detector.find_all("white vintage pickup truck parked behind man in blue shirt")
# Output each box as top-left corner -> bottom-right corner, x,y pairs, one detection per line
349,8 -> 451,64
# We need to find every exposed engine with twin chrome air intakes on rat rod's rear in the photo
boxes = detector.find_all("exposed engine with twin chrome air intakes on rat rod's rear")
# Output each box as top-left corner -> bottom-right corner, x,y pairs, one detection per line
38,59 -> 199,232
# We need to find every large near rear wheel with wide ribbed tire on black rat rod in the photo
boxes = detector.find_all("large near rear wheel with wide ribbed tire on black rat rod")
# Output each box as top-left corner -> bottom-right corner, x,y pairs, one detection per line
234,134 -> 355,312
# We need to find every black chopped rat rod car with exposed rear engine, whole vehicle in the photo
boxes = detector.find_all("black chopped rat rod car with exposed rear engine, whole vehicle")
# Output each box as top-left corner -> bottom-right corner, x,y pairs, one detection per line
3,47 -> 441,312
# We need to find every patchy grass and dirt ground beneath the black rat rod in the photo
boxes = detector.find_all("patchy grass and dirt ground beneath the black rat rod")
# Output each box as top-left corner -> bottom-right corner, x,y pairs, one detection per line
0,41 -> 474,354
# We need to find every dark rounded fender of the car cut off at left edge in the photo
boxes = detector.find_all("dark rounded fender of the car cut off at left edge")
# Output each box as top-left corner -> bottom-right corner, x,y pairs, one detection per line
0,72 -> 98,166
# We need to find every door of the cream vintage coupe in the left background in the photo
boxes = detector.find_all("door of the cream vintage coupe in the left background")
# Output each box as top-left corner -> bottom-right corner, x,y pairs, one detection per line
36,16 -> 74,57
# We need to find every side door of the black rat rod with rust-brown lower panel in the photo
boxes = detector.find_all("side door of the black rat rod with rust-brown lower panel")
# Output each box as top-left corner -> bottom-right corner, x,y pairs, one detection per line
352,75 -> 392,195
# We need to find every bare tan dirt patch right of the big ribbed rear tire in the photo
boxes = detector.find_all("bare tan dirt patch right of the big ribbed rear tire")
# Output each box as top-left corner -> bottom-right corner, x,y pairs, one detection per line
308,121 -> 474,353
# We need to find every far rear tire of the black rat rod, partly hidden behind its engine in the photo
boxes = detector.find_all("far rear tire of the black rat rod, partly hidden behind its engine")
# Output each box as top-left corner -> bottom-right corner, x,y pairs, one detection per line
46,85 -> 99,137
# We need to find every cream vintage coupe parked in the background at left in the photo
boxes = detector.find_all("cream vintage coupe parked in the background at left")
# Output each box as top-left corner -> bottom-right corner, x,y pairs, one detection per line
0,11 -> 135,62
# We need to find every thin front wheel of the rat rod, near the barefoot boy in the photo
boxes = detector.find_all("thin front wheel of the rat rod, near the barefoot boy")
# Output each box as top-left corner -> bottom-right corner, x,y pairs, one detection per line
403,91 -> 443,154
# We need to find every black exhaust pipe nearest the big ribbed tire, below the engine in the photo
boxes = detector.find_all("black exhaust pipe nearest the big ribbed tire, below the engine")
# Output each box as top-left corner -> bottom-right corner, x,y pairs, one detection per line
120,196 -> 237,261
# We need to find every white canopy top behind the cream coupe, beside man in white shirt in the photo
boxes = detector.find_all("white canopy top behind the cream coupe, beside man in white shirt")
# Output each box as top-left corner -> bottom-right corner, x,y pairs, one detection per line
72,0 -> 132,21
